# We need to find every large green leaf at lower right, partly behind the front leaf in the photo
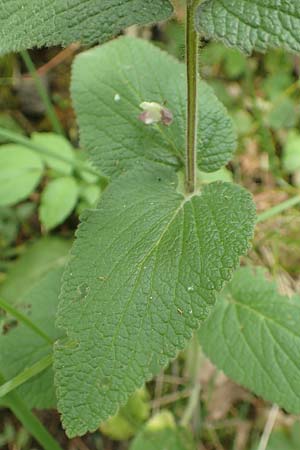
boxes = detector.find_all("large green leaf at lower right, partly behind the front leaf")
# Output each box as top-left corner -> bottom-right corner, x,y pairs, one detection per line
200,268 -> 300,414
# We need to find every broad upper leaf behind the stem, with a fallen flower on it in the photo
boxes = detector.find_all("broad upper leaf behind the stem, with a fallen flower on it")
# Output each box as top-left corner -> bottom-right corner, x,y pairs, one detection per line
72,37 -> 236,176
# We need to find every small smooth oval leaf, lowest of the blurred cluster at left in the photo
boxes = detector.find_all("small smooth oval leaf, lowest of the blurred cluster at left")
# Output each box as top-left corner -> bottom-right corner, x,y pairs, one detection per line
39,177 -> 79,230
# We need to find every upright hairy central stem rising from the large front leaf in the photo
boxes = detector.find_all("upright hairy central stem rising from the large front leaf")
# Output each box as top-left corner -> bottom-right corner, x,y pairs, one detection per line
185,0 -> 199,194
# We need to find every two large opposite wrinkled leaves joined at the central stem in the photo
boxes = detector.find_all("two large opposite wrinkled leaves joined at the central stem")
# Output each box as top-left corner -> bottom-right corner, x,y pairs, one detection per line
54,33 -> 255,436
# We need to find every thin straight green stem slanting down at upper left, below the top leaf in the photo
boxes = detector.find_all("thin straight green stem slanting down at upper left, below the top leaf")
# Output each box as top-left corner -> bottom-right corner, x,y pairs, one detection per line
20,50 -> 64,135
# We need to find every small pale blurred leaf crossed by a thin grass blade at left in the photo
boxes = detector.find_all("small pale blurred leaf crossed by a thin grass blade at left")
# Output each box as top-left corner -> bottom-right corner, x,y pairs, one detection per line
31,133 -> 75,175
